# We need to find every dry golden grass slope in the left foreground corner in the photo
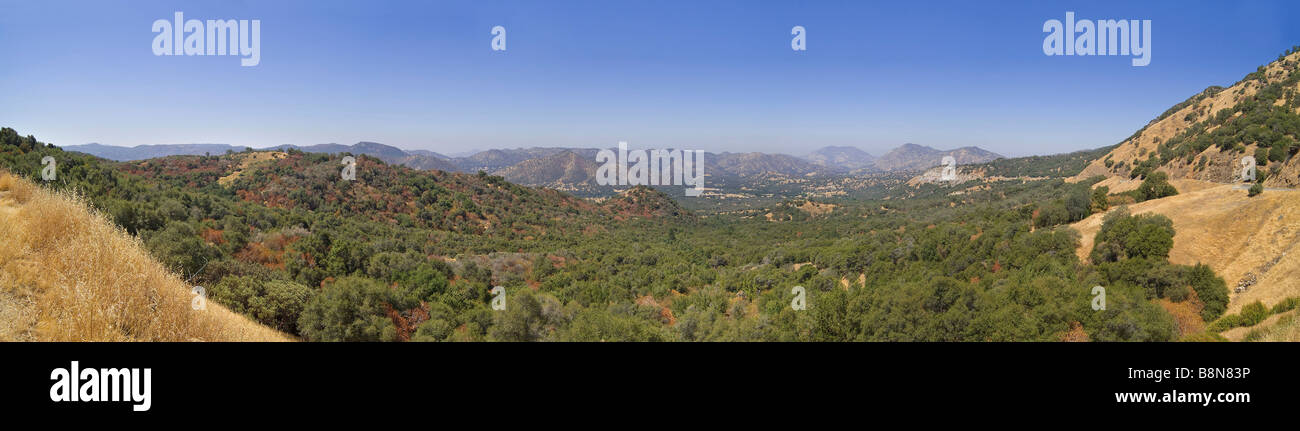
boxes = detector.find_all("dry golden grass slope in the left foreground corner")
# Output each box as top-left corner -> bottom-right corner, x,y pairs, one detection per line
0,171 -> 290,341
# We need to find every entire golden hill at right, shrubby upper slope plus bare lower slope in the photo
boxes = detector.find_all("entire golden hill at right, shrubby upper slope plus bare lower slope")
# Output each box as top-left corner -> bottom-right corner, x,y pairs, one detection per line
1069,48 -> 1300,340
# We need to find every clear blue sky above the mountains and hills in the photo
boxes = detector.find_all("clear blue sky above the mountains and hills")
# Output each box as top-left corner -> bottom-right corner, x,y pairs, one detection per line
0,0 -> 1300,156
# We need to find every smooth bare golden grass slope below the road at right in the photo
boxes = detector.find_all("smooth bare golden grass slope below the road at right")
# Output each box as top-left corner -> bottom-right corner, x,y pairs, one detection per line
1071,180 -> 1300,313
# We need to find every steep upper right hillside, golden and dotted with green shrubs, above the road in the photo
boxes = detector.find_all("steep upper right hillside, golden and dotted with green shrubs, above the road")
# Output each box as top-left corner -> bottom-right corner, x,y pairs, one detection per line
1075,48 -> 1300,187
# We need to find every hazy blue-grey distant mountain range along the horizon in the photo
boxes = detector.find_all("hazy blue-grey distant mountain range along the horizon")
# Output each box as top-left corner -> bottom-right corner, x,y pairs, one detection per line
64,142 -> 1002,188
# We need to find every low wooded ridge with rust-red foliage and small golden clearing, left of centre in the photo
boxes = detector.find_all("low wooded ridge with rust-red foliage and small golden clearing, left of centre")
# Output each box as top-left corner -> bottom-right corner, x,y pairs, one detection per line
120,151 -> 606,234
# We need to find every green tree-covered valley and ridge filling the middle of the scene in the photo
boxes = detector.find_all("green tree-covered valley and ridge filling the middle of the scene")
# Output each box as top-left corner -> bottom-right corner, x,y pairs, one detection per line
0,129 -> 1227,341
